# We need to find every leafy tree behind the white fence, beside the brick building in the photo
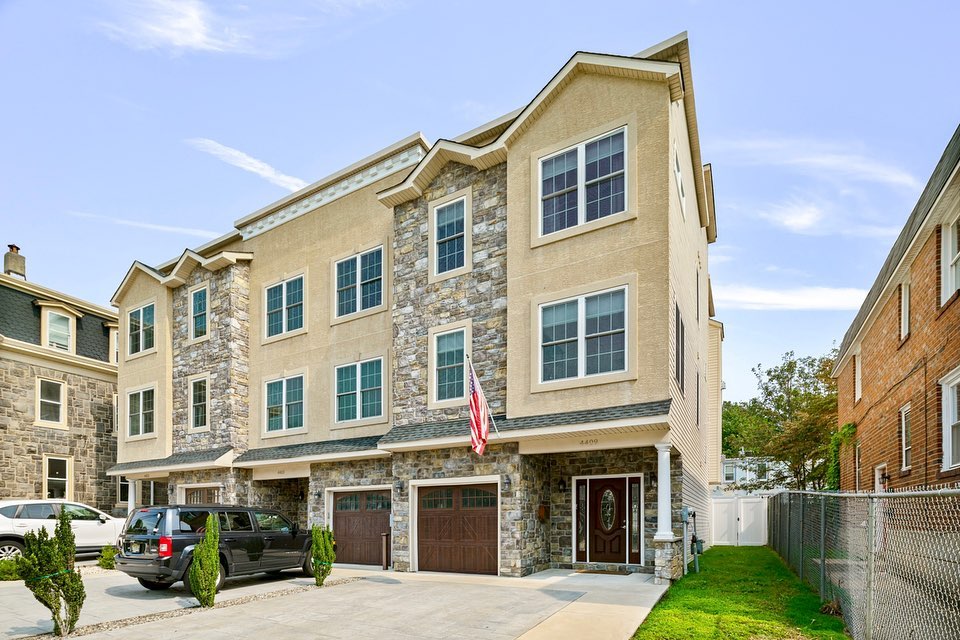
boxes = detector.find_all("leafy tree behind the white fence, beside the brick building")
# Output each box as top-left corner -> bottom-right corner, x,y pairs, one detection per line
723,349 -> 837,489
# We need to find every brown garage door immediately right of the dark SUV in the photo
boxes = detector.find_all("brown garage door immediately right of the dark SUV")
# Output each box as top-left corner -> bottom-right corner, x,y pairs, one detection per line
333,489 -> 390,564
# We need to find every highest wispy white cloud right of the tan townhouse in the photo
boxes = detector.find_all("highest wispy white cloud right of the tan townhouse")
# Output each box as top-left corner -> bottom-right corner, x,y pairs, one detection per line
711,136 -> 922,190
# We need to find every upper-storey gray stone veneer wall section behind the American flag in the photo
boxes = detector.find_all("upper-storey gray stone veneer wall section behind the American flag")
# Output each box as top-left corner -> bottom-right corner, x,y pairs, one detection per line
393,162 -> 507,425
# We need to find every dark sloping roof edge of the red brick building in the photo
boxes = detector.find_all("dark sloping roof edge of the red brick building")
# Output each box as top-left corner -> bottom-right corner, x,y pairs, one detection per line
833,126 -> 960,376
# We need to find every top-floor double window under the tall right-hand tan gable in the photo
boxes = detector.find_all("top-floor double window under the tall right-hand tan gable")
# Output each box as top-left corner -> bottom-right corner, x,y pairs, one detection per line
540,129 -> 626,236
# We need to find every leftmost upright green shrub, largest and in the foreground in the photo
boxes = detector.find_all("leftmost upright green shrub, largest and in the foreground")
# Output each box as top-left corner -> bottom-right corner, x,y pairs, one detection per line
17,509 -> 87,638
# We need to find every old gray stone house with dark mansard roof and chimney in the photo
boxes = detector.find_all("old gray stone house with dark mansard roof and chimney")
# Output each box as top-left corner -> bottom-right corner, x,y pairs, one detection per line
0,245 -> 118,512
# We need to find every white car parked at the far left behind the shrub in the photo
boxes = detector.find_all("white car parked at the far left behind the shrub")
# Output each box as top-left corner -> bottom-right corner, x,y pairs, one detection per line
0,500 -> 125,560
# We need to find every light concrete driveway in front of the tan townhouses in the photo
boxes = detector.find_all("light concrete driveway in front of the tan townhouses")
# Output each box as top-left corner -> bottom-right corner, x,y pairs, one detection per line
0,567 -> 666,640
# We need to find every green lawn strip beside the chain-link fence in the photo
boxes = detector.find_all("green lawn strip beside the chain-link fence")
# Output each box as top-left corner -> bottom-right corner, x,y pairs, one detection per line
633,547 -> 848,640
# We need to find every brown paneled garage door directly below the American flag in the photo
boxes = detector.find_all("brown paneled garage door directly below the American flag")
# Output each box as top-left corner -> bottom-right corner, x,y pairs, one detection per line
417,484 -> 497,575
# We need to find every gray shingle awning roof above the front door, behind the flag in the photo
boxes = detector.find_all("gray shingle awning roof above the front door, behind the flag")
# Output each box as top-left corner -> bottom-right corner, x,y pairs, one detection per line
380,400 -> 670,445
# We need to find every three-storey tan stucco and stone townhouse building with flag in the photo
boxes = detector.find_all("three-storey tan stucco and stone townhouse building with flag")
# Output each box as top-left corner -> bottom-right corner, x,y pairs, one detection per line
111,34 -> 722,579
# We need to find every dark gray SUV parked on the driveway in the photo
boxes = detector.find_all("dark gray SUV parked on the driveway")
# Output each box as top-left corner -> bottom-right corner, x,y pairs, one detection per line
116,504 -> 313,591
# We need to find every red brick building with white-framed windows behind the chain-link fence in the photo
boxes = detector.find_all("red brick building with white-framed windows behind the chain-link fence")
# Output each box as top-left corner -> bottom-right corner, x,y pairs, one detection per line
834,128 -> 960,491
